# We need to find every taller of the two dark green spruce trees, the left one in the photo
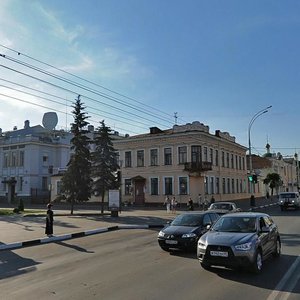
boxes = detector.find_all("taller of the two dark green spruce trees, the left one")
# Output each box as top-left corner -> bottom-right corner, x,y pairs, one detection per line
62,96 -> 92,214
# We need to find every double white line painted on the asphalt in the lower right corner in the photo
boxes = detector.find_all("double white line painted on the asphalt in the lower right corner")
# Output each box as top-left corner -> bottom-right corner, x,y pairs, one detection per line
267,256 -> 300,300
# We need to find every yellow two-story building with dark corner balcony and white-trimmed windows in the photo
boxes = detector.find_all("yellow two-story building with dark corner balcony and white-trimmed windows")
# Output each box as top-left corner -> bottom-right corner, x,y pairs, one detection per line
114,121 -> 249,205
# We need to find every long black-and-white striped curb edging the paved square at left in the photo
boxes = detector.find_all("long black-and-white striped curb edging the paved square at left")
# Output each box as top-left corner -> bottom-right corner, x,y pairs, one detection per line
0,224 -> 165,251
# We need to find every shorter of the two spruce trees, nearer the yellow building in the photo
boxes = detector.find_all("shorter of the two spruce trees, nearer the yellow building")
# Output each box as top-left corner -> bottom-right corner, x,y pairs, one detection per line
91,120 -> 120,213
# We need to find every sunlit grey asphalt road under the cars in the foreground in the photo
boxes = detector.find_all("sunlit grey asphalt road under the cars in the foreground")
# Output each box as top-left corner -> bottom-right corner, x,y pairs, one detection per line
0,208 -> 300,300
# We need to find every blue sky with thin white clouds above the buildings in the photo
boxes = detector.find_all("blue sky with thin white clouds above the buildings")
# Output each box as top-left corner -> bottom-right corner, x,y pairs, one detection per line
0,0 -> 300,155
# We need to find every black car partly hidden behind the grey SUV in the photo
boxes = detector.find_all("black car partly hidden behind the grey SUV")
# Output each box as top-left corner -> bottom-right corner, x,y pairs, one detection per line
157,211 -> 219,251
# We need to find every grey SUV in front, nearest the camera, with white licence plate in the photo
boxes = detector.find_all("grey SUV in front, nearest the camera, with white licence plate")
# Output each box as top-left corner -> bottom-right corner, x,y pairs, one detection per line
197,212 -> 281,273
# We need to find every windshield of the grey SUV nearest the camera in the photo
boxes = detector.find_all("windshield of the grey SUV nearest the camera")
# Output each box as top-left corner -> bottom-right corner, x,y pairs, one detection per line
212,217 -> 256,232
